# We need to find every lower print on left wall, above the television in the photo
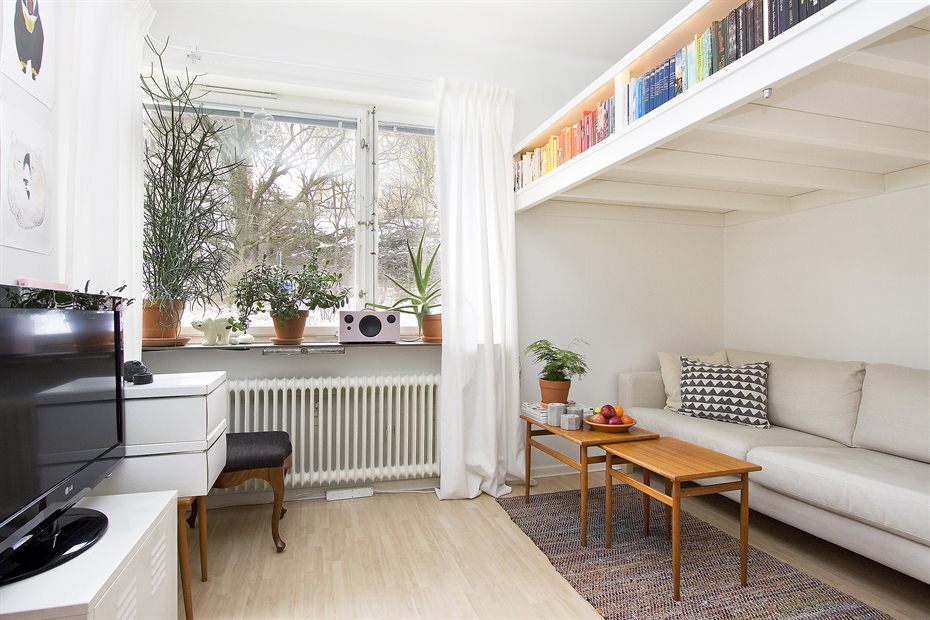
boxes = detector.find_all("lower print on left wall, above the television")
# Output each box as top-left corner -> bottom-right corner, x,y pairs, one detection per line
0,77 -> 56,254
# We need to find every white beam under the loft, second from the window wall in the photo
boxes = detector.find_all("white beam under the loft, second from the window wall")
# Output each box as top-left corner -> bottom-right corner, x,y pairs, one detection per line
616,148 -> 885,193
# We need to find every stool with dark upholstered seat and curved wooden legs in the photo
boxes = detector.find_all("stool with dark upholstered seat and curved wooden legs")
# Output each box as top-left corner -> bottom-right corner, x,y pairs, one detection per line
213,431 -> 293,553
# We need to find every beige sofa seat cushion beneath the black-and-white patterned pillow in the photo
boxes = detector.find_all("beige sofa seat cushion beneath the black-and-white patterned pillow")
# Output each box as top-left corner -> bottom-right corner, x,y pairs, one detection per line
627,407 -> 842,460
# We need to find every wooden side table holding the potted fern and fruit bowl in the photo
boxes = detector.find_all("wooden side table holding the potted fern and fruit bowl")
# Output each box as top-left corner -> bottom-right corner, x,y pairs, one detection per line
520,415 -> 659,546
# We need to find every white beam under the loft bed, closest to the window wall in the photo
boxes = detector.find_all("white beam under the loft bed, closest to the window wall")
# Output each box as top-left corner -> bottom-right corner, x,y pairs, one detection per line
559,181 -> 791,213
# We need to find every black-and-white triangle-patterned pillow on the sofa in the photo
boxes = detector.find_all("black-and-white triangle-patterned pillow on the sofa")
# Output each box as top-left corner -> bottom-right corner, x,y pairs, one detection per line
679,357 -> 769,428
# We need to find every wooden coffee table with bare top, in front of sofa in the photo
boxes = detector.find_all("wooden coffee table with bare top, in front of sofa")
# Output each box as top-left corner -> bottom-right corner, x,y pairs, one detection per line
601,437 -> 762,601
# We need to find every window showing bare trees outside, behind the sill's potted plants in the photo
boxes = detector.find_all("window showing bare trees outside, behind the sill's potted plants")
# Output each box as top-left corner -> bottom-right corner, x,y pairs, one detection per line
144,105 -> 439,328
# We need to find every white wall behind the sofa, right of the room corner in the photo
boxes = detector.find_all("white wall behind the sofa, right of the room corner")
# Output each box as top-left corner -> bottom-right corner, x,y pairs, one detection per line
724,185 -> 930,368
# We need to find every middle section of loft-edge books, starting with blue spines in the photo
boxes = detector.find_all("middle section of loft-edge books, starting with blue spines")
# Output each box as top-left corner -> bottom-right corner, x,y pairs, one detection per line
624,0 -> 760,122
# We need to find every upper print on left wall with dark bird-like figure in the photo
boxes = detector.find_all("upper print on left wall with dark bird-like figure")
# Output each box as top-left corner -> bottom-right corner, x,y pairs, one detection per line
0,0 -> 58,108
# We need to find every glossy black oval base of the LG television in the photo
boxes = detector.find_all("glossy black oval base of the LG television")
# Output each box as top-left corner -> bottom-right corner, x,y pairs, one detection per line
0,508 -> 108,586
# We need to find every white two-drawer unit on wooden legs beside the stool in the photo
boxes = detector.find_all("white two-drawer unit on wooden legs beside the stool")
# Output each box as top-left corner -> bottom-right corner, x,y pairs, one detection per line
94,372 -> 228,497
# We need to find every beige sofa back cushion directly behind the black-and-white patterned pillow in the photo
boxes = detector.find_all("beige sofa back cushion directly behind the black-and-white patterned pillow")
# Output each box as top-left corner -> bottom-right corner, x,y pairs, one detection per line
727,349 -> 865,446
